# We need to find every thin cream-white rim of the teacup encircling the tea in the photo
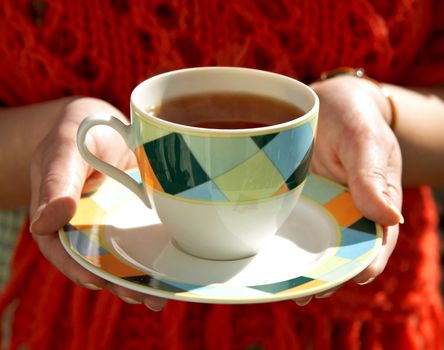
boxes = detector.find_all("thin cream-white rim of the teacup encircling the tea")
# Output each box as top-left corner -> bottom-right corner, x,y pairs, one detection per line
130,66 -> 319,135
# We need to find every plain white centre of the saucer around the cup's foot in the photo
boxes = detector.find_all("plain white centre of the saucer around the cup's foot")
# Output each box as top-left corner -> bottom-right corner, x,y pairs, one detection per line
102,194 -> 339,286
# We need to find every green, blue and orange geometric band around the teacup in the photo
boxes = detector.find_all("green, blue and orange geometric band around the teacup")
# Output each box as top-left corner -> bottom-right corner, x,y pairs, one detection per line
136,123 -> 313,203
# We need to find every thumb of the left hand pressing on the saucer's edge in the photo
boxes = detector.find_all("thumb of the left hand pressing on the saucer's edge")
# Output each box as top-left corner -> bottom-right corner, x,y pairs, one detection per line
30,132 -> 88,234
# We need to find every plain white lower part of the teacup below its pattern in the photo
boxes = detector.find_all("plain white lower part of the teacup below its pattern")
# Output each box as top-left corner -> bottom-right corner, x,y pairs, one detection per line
152,185 -> 303,260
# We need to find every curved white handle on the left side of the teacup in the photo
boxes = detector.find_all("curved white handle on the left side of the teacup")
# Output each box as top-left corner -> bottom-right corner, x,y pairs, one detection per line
77,113 -> 151,208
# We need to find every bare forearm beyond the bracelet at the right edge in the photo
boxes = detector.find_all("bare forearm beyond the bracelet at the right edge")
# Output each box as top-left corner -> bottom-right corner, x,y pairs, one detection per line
387,85 -> 444,186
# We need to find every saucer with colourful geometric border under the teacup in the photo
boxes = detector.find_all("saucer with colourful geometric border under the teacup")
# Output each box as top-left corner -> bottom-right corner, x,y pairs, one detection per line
59,170 -> 382,304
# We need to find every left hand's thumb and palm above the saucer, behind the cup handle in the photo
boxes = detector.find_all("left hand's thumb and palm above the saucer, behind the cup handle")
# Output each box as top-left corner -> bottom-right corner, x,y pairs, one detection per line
30,98 -> 129,234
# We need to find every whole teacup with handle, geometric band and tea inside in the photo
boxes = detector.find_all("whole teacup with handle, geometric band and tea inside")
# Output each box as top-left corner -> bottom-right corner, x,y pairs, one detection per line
77,67 -> 319,260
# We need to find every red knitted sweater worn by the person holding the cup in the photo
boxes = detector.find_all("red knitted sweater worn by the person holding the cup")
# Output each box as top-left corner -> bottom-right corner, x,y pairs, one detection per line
0,0 -> 444,350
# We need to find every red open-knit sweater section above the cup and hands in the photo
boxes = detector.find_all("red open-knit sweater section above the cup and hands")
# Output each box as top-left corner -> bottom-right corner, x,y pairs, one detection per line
0,0 -> 444,110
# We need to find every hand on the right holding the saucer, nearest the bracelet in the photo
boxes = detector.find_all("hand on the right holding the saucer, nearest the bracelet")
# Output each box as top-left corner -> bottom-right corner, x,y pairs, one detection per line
297,75 -> 403,304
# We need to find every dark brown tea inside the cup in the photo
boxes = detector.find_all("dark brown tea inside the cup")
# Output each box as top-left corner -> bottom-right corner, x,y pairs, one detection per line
148,92 -> 304,129
